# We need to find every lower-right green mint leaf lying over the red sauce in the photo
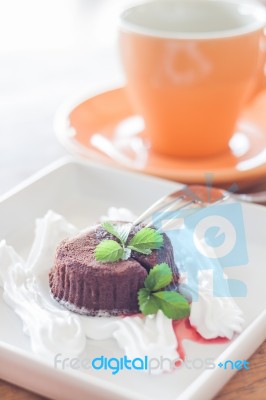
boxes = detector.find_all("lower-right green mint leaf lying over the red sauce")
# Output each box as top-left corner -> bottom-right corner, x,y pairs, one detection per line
152,291 -> 190,319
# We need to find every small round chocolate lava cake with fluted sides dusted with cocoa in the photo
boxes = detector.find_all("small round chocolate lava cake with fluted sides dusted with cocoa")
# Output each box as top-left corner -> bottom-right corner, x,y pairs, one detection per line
49,225 -> 179,316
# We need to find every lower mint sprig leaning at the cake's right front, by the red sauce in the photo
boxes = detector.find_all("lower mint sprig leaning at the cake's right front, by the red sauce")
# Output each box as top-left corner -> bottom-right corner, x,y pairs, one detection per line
138,263 -> 190,319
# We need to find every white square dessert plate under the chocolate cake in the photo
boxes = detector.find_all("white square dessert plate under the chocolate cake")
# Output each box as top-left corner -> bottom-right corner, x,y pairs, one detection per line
0,159 -> 266,400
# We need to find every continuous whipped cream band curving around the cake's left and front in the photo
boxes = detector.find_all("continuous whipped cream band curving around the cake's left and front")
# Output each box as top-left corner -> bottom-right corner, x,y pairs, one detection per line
0,211 -> 179,373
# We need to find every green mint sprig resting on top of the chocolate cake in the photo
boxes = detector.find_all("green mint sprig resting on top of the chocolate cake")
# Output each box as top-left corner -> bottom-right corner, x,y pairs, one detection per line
94,222 -> 163,262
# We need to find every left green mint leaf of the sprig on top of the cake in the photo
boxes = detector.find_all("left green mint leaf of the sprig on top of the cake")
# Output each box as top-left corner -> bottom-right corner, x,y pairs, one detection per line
94,240 -> 124,262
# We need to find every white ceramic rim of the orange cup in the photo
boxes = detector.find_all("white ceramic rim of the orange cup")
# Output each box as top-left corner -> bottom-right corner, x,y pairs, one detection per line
119,0 -> 266,40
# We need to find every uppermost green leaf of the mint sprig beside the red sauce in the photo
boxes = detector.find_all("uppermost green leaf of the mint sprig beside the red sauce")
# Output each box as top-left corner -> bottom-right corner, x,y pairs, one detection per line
144,263 -> 173,292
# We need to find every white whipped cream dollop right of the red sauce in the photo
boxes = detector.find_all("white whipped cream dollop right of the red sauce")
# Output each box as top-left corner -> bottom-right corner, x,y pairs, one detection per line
181,270 -> 244,339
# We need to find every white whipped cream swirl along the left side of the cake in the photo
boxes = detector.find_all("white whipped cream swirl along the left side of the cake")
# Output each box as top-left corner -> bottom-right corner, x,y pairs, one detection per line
0,211 -> 85,357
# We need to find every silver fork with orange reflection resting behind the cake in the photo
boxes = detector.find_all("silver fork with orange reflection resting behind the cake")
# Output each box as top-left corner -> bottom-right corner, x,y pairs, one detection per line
133,185 -> 266,228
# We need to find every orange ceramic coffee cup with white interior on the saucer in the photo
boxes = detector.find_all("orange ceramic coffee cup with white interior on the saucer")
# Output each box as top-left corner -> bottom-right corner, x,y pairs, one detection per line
119,0 -> 266,157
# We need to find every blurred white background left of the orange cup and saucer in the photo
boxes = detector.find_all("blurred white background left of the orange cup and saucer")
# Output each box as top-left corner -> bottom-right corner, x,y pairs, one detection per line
0,0 -> 134,194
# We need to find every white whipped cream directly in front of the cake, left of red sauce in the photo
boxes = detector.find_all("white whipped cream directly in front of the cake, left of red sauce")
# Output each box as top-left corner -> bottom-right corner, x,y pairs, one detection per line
82,311 -> 180,374
